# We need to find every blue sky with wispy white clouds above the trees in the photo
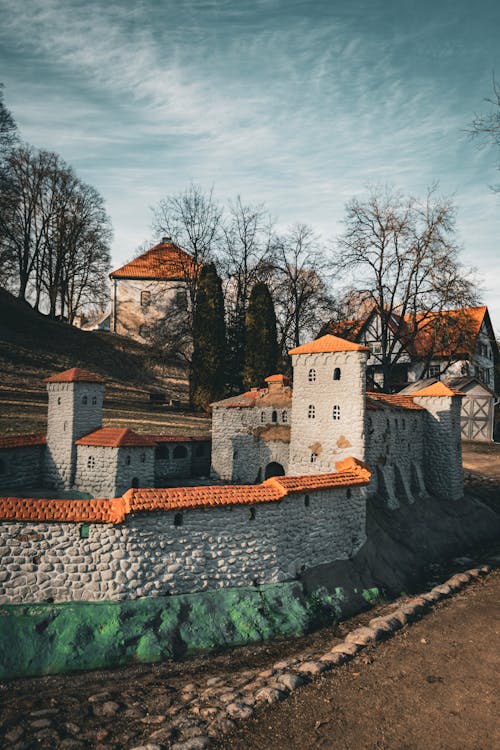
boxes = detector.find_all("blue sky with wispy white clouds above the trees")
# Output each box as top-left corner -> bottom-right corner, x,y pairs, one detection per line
0,0 -> 500,330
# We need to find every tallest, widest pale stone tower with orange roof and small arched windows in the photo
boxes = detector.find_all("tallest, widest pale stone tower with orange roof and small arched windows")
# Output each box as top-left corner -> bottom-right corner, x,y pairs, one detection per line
288,334 -> 369,475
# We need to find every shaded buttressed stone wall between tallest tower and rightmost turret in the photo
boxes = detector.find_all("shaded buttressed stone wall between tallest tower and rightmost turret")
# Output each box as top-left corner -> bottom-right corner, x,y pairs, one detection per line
366,409 -> 425,508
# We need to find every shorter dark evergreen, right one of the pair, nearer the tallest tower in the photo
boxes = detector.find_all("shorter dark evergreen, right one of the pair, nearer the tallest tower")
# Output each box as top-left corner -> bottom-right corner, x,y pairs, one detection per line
243,282 -> 278,388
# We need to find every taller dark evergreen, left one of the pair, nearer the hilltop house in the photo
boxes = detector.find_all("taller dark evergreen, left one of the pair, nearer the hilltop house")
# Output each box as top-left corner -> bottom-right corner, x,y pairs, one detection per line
190,263 -> 226,410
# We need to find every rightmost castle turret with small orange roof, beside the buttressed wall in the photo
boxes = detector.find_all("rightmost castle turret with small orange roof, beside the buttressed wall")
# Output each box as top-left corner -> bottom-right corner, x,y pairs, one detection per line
413,382 -> 464,500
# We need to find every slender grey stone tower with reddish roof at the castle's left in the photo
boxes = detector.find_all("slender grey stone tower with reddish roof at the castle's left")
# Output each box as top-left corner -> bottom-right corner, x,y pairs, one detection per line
44,367 -> 104,489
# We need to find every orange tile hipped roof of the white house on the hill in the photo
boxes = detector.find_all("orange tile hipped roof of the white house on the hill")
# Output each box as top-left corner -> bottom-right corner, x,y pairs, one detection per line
110,241 -> 196,281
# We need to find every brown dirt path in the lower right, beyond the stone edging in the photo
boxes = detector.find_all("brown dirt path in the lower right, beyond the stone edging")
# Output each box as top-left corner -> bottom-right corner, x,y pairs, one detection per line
215,571 -> 500,750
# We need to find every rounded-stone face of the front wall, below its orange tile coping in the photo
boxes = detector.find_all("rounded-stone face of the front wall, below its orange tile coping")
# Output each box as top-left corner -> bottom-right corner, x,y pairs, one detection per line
0,487 -> 366,604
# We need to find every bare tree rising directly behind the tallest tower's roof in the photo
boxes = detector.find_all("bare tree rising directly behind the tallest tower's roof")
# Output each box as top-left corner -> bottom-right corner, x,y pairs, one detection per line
272,224 -> 334,357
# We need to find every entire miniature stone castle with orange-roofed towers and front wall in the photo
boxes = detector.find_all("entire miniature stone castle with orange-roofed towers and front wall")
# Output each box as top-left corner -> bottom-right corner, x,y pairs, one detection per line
0,335 -> 463,603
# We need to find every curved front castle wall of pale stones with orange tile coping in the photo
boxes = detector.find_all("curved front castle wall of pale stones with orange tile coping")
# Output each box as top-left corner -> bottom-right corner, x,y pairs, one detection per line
0,468 -> 369,604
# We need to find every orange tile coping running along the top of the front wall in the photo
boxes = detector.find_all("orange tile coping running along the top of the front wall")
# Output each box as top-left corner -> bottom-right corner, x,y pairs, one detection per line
0,459 -> 370,523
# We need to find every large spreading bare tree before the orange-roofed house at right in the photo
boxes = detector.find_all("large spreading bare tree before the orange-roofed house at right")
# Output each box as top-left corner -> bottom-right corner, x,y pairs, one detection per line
335,188 -> 477,390
